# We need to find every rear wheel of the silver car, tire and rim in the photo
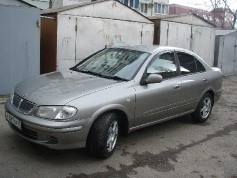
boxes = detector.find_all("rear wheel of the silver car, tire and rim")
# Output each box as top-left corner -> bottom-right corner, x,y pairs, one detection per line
192,93 -> 213,123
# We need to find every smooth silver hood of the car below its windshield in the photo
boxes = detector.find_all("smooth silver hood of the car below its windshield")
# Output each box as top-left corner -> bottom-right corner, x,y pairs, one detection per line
14,71 -> 121,105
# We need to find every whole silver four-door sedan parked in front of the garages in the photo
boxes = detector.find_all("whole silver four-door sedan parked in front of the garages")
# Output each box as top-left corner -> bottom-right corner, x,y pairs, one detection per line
5,45 -> 222,158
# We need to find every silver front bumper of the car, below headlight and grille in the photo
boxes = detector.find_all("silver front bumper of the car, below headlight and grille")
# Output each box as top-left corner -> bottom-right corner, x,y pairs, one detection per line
5,99 -> 90,150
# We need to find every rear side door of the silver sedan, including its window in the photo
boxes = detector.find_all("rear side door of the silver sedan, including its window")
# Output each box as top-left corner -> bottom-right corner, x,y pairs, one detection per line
177,52 -> 208,113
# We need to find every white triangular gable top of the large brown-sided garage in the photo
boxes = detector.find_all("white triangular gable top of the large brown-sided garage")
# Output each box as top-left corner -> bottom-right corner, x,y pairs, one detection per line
41,0 -> 153,24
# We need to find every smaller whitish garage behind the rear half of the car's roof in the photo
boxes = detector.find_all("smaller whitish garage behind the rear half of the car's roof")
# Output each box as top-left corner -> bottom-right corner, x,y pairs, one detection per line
151,14 -> 215,66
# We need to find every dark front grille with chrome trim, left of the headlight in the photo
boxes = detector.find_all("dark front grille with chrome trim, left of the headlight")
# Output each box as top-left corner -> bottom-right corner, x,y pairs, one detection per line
12,94 -> 36,114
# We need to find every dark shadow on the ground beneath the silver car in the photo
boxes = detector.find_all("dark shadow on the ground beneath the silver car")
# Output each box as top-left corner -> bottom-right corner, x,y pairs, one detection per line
7,115 -> 209,164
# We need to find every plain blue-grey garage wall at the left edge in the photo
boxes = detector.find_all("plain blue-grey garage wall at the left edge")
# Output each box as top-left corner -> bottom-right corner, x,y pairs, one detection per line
0,5 -> 40,95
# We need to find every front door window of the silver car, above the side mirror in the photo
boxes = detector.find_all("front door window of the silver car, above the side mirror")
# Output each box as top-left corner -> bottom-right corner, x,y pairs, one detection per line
147,53 -> 177,79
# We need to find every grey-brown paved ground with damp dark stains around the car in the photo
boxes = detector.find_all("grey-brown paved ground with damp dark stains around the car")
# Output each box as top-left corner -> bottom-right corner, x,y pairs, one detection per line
0,76 -> 237,178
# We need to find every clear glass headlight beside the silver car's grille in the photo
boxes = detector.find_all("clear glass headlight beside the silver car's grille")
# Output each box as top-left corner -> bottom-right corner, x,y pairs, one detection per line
34,106 -> 77,120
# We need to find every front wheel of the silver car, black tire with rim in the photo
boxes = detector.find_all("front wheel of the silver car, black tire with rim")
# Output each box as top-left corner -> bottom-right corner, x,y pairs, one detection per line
88,113 -> 119,159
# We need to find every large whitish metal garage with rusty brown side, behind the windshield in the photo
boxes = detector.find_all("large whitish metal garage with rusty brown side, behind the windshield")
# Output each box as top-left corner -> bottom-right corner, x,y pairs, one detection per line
41,0 -> 154,73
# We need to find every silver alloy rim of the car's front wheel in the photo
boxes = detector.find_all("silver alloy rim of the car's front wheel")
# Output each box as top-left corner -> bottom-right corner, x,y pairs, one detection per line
107,121 -> 118,152
